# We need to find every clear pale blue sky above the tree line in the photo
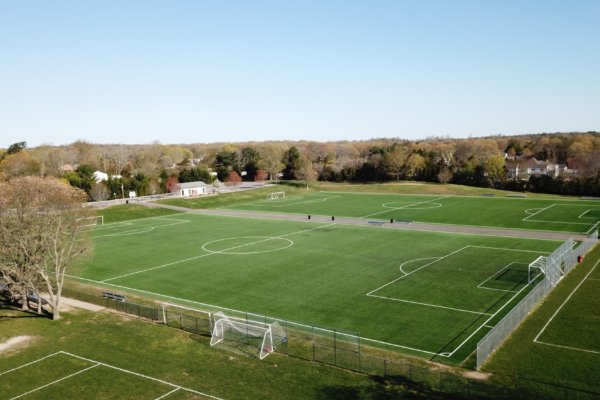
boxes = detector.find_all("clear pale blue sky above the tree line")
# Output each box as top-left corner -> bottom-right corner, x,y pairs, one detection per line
0,0 -> 600,147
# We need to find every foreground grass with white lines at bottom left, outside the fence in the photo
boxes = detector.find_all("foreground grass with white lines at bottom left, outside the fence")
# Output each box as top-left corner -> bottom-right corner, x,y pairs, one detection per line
0,309 -> 458,399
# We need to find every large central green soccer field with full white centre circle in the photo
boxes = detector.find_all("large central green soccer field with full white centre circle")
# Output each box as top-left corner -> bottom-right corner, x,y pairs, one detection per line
72,214 -> 559,363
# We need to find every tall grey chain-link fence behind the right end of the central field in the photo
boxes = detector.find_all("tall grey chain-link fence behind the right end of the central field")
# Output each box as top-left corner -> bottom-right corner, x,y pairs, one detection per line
477,231 -> 598,370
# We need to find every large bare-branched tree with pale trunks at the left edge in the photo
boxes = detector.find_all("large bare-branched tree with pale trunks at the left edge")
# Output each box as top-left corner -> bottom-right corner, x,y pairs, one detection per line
0,177 -> 91,320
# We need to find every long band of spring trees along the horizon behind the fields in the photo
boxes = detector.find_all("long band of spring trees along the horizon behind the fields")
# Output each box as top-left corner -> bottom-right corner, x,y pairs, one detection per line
0,132 -> 600,200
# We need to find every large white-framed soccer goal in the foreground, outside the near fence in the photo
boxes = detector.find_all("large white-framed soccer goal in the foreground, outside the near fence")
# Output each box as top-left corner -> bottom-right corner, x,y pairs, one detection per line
210,312 -> 287,360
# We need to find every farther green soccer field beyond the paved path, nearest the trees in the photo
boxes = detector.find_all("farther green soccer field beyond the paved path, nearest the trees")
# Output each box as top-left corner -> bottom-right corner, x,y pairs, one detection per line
221,192 -> 600,233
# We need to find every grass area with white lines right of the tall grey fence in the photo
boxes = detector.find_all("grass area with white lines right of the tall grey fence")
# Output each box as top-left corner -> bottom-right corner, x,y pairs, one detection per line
484,246 -> 600,398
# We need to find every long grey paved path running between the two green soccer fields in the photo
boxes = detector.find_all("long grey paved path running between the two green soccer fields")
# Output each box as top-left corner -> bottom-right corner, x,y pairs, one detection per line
140,202 -> 587,241
